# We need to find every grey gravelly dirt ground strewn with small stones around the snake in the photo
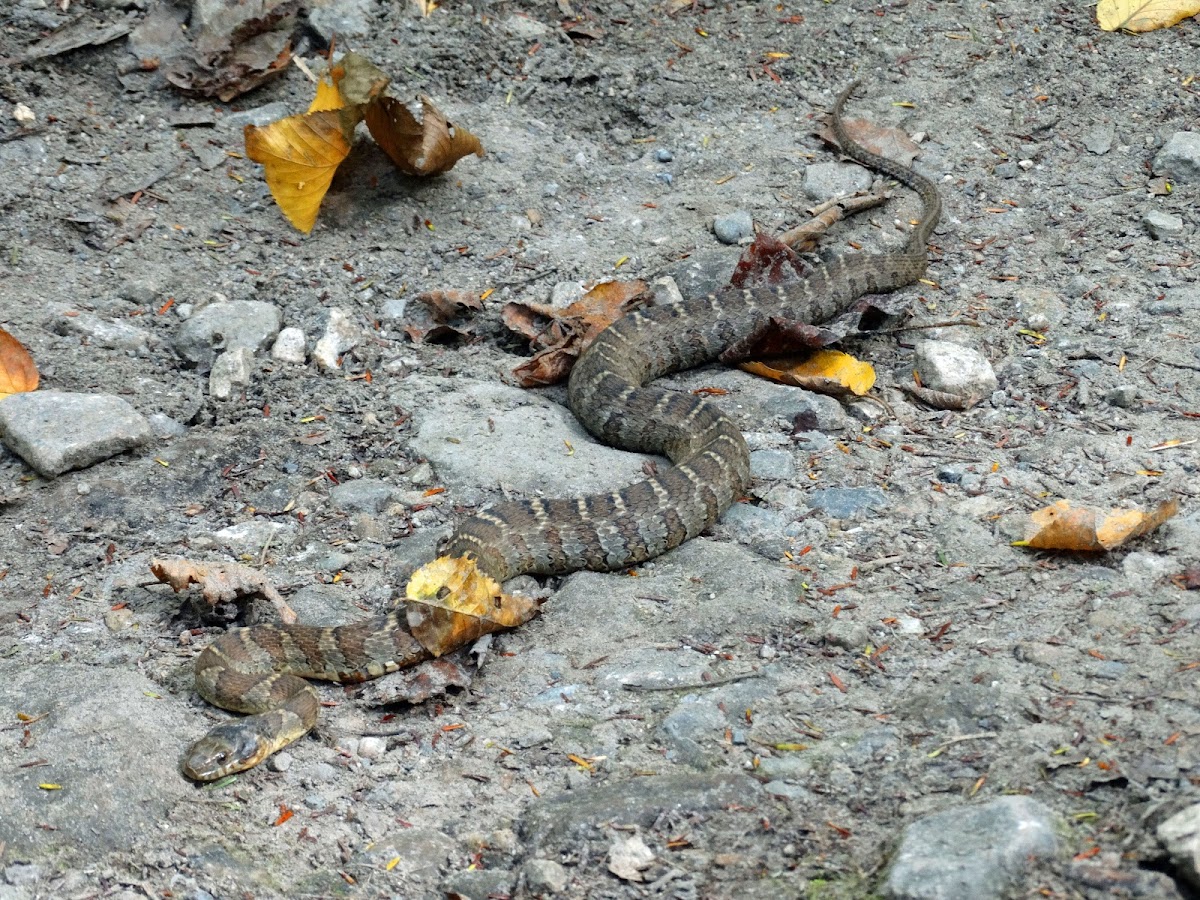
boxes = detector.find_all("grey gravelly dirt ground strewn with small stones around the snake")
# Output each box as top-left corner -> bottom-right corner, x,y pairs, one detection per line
0,0 -> 1200,900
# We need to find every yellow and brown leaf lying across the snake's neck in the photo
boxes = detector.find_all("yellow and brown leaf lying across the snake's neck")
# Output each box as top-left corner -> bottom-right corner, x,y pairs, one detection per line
406,557 -> 538,656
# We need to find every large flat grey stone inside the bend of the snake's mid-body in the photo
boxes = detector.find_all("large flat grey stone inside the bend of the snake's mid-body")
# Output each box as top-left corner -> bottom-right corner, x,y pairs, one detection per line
410,383 -> 652,497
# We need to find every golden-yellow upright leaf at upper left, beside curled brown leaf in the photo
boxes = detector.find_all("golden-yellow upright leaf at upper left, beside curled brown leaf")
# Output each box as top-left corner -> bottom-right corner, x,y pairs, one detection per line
245,107 -> 361,234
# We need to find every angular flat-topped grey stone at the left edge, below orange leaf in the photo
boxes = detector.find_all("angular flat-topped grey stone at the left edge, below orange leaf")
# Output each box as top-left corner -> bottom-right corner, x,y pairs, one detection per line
0,391 -> 154,478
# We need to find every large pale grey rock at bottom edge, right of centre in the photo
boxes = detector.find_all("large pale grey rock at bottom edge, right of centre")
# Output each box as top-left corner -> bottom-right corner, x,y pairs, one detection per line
883,797 -> 1058,900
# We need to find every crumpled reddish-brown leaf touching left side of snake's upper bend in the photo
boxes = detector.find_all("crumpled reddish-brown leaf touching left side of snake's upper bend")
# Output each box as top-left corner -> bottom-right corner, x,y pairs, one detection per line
500,281 -> 649,388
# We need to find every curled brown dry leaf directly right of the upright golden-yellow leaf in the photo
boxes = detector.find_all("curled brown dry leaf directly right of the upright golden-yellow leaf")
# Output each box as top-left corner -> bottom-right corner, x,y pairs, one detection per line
366,95 -> 484,176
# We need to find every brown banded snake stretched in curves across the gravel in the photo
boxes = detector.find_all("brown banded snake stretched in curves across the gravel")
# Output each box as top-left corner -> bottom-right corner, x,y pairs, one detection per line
182,82 -> 941,781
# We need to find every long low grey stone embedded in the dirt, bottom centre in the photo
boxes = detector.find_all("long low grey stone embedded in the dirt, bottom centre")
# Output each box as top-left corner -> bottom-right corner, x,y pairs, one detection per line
521,773 -> 766,851
